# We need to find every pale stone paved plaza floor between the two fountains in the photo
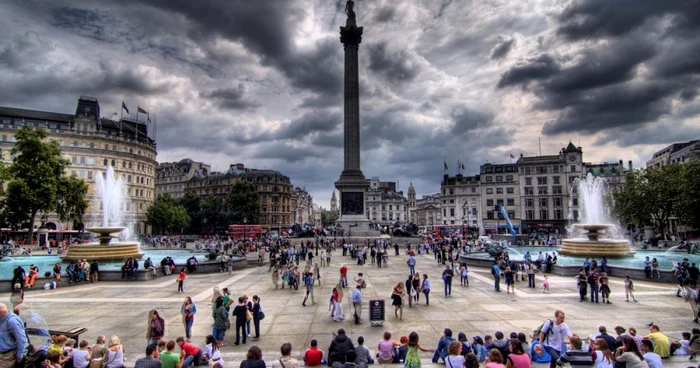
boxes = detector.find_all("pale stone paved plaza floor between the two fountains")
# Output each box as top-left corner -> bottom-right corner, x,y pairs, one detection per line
0,249 -> 696,367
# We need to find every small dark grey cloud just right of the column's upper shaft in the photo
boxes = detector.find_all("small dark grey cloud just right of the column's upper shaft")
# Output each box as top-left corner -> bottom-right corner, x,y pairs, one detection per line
367,42 -> 420,82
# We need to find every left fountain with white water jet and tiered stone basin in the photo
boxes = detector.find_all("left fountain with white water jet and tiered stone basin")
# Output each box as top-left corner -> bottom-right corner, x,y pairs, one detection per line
62,166 -> 143,262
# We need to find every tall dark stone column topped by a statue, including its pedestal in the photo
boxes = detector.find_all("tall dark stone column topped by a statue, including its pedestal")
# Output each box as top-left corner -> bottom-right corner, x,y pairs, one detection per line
335,0 -> 374,236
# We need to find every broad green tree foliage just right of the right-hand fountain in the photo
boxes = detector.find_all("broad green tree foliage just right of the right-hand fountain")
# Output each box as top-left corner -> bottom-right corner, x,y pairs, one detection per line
613,164 -> 686,234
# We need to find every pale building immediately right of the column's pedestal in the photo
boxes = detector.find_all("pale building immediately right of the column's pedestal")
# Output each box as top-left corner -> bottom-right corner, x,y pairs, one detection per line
366,176 -> 409,227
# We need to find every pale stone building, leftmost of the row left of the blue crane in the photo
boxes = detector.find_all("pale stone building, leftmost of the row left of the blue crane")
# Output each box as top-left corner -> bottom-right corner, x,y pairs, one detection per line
439,174 -> 484,230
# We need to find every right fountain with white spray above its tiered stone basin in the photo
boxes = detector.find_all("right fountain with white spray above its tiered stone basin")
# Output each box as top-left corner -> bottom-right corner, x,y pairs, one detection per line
559,173 -> 632,257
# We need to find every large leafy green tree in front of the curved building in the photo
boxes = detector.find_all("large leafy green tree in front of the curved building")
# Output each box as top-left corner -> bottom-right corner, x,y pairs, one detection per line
2,125 -> 87,241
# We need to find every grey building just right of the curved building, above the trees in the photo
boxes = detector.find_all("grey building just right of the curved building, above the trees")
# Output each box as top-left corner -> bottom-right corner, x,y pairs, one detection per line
156,158 -> 211,199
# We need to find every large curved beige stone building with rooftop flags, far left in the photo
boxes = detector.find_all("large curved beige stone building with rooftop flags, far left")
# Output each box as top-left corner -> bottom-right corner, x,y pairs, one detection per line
0,96 -> 157,235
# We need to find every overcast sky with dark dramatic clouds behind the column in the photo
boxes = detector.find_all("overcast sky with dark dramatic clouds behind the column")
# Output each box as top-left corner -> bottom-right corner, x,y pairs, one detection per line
0,0 -> 700,207
